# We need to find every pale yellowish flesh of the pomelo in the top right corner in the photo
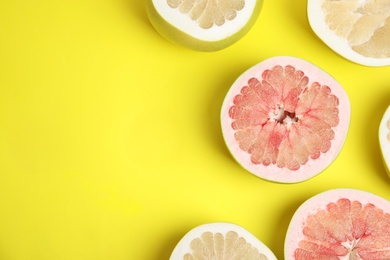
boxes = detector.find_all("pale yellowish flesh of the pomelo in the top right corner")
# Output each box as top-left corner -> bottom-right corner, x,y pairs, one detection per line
322,0 -> 390,58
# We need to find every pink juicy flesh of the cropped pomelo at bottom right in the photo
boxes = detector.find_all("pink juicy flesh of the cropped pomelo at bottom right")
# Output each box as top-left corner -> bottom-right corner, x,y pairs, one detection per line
294,198 -> 390,259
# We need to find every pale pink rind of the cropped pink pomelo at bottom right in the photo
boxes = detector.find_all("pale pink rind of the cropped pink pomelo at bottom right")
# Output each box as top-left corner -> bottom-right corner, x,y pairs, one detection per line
284,188 -> 390,260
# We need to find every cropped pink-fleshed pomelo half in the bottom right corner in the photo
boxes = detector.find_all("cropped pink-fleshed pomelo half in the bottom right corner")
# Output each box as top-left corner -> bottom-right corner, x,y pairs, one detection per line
285,189 -> 390,260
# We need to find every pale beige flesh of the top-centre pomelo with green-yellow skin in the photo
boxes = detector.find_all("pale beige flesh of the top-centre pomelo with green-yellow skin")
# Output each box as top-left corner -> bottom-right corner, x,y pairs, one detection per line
167,0 -> 245,29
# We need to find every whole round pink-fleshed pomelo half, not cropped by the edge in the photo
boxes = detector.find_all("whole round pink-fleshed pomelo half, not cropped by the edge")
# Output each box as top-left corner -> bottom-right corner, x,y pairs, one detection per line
221,56 -> 350,183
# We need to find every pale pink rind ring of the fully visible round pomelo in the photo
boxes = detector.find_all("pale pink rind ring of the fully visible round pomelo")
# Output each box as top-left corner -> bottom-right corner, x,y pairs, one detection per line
221,56 -> 351,183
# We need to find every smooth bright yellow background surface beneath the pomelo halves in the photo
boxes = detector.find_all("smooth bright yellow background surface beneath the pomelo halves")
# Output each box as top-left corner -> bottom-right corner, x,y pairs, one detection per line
0,0 -> 390,260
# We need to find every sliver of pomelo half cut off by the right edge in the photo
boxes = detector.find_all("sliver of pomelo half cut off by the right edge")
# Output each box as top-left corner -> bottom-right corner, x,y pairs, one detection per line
379,106 -> 390,177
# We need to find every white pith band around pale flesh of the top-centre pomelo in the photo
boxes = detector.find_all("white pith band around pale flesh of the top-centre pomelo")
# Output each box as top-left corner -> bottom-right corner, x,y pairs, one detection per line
152,0 -> 257,41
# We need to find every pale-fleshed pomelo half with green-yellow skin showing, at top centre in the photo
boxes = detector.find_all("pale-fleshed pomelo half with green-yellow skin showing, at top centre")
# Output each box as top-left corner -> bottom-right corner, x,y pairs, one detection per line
146,0 -> 263,51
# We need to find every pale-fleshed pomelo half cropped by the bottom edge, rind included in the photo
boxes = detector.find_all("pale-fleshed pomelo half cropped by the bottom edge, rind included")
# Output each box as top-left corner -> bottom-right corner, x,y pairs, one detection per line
170,222 -> 276,260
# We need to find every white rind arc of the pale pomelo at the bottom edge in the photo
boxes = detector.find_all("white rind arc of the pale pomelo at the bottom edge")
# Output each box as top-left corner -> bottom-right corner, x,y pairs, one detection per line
169,222 -> 276,260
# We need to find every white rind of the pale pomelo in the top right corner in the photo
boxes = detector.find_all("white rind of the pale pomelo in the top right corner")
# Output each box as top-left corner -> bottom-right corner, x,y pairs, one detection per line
307,0 -> 390,67
